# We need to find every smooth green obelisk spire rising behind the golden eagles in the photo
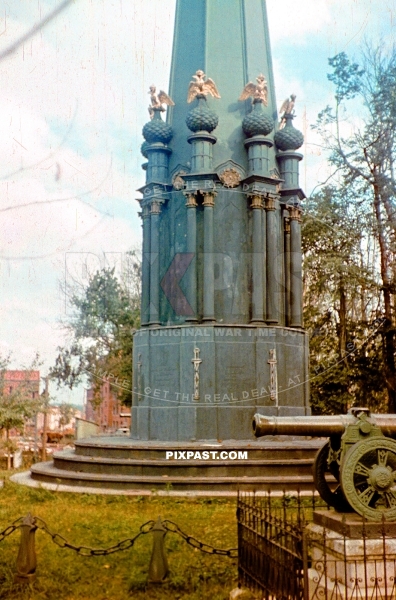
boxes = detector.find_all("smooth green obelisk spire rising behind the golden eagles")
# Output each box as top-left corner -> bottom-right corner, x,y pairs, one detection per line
168,0 -> 277,171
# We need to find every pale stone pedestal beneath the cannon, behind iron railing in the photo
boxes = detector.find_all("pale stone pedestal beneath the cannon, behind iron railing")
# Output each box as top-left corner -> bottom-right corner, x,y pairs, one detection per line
306,511 -> 396,600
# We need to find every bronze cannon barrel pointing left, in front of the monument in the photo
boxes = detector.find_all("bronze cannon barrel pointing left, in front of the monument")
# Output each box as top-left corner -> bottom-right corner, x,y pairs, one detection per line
253,413 -> 396,437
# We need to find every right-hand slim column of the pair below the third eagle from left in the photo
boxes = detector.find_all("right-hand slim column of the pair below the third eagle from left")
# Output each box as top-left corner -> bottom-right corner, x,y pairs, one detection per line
265,194 -> 279,323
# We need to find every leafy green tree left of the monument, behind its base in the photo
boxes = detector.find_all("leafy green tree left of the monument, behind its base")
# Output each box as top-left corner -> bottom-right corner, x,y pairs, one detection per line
51,253 -> 140,405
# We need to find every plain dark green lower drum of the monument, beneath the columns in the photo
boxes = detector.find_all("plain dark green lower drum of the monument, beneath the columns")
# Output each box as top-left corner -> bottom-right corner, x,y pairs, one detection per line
132,324 -> 311,442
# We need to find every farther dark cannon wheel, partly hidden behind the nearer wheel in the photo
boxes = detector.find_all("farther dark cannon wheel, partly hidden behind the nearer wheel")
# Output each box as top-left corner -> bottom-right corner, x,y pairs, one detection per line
313,442 -> 351,512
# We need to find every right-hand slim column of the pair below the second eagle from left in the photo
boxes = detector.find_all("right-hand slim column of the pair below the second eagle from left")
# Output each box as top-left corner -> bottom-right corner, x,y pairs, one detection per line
201,191 -> 216,322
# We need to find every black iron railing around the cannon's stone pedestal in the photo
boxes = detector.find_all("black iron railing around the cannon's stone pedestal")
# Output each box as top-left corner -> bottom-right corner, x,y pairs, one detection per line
237,493 -> 396,600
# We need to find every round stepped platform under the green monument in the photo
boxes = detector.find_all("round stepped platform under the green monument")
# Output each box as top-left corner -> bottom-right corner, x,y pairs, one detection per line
23,436 -> 323,496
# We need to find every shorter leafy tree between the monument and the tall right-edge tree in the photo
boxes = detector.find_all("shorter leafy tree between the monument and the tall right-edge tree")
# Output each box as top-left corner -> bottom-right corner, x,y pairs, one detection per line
302,186 -> 386,414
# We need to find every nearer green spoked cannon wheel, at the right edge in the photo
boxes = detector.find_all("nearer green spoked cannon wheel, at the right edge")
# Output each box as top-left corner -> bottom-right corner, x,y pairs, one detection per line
340,437 -> 396,521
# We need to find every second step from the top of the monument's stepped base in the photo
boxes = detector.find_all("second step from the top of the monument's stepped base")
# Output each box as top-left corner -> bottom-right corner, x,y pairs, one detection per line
53,451 -> 313,477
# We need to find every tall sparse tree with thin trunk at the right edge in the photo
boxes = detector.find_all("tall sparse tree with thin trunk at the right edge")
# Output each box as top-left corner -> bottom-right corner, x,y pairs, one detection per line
314,44 -> 396,412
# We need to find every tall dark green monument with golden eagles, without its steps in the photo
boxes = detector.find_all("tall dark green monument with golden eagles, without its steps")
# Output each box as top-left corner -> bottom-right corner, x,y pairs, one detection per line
132,0 -> 310,442
